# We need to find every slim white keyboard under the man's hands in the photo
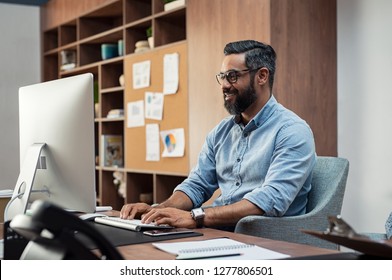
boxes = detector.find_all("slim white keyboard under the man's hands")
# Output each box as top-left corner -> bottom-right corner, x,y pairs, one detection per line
94,216 -> 173,231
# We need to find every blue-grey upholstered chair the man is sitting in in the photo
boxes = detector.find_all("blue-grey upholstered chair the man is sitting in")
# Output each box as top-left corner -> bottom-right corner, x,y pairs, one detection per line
235,156 -> 349,250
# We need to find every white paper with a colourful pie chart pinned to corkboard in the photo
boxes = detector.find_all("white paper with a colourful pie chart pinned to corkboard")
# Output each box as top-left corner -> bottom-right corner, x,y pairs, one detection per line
161,128 -> 185,157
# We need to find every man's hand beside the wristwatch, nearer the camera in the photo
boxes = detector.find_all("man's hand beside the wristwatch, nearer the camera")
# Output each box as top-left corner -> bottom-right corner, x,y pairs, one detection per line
142,207 -> 196,228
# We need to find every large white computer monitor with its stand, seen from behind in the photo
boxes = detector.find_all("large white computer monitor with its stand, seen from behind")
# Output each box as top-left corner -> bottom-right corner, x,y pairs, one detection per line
4,73 -> 96,221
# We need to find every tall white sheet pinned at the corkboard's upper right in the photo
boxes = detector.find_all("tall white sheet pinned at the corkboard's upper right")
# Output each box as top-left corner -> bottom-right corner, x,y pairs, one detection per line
163,53 -> 179,94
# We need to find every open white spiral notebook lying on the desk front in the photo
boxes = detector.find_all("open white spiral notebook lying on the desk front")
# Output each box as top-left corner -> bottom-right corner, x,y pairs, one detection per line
152,238 -> 290,260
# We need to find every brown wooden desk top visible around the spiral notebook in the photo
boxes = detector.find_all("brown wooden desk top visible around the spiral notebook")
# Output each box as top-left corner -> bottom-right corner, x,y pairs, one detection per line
117,228 -> 339,260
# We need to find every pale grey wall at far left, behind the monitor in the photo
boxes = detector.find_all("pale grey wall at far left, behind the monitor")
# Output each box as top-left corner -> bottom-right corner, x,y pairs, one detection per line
0,3 -> 41,189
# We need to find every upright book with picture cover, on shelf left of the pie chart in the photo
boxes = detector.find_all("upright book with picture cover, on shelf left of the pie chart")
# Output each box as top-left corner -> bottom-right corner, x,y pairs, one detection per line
101,134 -> 124,167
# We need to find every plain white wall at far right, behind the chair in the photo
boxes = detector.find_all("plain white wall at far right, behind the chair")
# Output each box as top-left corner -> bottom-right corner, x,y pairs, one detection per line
338,0 -> 392,232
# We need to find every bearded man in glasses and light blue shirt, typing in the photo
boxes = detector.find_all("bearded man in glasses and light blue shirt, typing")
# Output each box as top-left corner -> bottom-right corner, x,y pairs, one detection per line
120,40 -> 316,228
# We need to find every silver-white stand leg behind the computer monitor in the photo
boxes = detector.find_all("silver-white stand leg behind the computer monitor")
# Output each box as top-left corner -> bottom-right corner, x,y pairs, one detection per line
4,143 -> 46,221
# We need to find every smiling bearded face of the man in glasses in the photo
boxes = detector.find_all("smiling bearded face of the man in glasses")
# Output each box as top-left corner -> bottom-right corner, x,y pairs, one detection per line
221,54 -> 257,115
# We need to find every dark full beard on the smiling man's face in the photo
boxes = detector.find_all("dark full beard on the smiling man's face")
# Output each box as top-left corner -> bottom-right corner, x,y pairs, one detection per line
223,84 -> 257,115
